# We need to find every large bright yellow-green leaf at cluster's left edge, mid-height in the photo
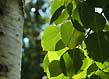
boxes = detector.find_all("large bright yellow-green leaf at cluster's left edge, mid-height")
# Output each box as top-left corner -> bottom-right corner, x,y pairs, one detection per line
41,26 -> 61,51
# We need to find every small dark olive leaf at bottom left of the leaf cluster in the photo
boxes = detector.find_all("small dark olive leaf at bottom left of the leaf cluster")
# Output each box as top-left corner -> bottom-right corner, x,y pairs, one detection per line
49,60 -> 61,77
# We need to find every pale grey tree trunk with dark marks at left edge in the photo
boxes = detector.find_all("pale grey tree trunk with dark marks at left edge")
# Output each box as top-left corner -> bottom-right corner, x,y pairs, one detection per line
0,0 -> 24,79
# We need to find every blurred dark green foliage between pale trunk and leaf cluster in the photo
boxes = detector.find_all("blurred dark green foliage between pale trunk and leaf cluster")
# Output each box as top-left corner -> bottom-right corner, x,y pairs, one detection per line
21,0 -> 49,79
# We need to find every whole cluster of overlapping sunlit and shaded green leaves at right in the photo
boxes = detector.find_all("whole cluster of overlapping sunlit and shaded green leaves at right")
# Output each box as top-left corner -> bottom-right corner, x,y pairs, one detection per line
42,0 -> 109,79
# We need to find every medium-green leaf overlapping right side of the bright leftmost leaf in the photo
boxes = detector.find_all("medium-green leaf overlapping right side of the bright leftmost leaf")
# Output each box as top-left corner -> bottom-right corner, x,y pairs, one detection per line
61,22 -> 84,48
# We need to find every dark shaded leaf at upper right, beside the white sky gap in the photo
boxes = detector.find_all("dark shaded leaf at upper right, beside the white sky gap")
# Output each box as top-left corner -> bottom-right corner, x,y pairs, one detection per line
78,2 -> 106,32
